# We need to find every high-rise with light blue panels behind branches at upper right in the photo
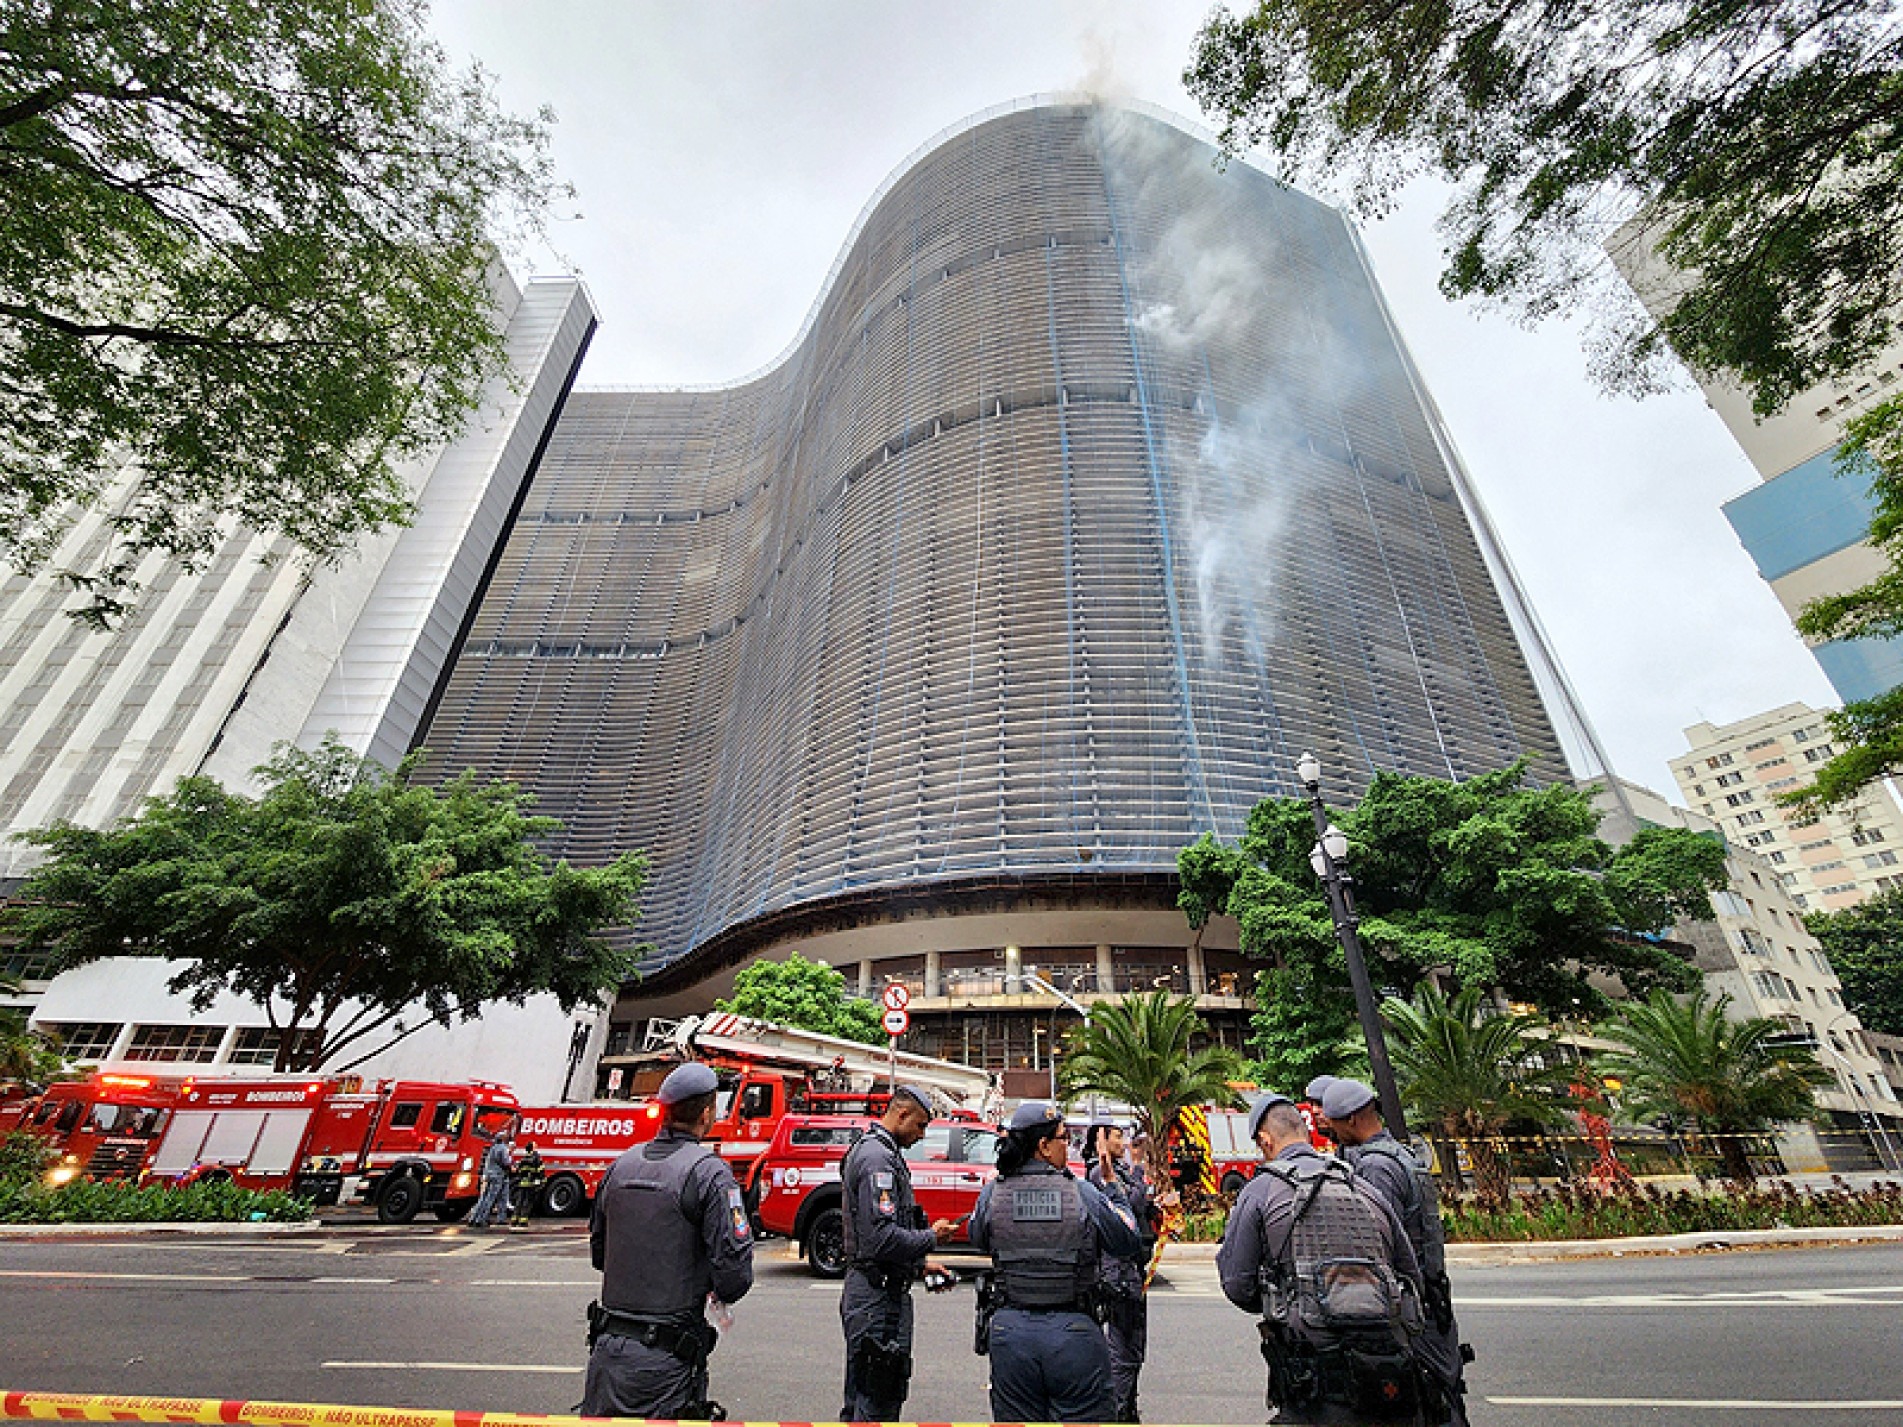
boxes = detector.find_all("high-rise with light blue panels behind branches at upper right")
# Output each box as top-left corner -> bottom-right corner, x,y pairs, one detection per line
1606,219 -> 1903,702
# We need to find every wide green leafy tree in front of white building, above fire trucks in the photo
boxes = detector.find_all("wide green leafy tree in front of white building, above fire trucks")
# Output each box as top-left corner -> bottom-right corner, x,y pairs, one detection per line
4,740 -> 647,1071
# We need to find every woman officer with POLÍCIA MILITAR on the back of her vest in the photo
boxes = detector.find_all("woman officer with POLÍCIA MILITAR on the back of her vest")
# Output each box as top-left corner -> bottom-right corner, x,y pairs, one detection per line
971,1100 -> 1144,1421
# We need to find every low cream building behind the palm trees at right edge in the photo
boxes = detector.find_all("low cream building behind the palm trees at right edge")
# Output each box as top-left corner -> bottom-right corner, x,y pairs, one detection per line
1600,780 -> 1903,1170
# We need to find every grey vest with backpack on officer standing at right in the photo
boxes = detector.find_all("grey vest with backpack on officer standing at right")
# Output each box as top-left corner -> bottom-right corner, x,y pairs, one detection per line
1262,1157 -> 1420,1347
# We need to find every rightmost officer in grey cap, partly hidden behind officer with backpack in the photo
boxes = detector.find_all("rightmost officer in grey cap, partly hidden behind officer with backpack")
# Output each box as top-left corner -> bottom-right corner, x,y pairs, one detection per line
1321,1081 -> 1473,1427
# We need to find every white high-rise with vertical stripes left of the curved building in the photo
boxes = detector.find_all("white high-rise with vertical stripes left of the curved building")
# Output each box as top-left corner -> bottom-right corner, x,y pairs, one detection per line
0,270 -> 596,1096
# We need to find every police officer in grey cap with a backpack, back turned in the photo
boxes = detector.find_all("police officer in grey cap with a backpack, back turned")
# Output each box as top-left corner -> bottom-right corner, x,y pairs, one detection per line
1216,1094 -> 1429,1427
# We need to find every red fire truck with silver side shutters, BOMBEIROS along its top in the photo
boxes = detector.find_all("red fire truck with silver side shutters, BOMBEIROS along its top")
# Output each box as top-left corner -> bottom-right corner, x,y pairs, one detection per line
145,1075 -> 518,1223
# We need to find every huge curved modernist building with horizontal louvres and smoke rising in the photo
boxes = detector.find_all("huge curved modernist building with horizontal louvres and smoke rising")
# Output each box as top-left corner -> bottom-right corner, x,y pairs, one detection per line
422,103 -> 1566,1064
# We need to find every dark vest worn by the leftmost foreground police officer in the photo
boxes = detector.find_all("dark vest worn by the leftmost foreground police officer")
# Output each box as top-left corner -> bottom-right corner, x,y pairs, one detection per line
601,1140 -> 714,1317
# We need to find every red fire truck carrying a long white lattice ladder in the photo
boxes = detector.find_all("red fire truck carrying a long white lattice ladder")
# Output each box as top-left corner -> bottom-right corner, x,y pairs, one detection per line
520,1012 -> 997,1214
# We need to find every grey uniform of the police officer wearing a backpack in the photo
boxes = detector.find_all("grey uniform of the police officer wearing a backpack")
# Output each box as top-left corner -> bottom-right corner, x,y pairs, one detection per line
1216,1144 -> 1422,1423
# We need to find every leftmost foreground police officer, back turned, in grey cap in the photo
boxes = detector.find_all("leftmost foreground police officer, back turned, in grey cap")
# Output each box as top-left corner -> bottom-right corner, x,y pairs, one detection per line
582,1062 -> 754,1419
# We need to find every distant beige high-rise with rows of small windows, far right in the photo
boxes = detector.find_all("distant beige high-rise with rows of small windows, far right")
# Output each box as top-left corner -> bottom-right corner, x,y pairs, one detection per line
1671,704 -> 1903,911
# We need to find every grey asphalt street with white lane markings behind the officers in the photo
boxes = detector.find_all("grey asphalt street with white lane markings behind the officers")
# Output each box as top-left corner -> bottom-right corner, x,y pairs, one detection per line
0,1225 -> 1903,1427
